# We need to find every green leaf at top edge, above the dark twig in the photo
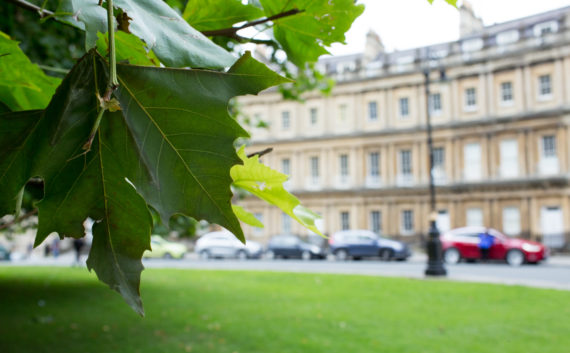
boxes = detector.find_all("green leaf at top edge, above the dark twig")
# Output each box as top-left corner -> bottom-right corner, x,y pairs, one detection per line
182,0 -> 263,31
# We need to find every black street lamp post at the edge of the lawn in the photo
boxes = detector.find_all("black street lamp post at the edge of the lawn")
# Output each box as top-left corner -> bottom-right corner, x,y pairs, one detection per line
424,67 -> 447,276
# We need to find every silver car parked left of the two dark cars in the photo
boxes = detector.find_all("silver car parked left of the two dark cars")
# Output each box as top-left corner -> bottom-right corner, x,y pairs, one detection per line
194,230 -> 263,260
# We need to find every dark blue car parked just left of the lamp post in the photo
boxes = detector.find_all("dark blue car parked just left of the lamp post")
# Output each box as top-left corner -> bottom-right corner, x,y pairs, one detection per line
329,230 -> 412,261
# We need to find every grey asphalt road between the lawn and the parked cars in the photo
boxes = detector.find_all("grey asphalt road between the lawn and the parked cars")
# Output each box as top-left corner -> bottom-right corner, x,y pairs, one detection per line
2,254 -> 570,290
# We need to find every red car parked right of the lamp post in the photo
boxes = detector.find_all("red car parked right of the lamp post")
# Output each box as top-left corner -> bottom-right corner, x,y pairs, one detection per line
441,227 -> 548,266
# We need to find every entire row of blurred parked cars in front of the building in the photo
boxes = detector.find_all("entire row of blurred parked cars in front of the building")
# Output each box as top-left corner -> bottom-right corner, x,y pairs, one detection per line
144,227 -> 549,266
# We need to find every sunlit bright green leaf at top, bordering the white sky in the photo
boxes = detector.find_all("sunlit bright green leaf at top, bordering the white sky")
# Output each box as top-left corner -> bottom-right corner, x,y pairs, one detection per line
260,0 -> 364,66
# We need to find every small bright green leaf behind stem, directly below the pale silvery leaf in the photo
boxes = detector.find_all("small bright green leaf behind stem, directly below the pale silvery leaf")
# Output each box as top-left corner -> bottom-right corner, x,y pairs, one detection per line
97,31 -> 160,66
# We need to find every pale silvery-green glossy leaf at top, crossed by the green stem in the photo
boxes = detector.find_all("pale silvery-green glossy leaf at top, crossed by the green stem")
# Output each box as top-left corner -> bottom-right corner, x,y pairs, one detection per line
59,0 -> 236,68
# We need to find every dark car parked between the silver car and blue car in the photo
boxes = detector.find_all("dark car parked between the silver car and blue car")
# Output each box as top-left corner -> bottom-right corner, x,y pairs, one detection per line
265,235 -> 326,260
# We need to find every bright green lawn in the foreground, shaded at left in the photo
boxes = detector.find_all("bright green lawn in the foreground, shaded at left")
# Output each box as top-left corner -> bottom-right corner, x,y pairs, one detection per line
0,267 -> 570,353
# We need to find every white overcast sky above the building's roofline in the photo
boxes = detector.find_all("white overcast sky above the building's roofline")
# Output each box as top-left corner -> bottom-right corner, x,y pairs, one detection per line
329,0 -> 570,55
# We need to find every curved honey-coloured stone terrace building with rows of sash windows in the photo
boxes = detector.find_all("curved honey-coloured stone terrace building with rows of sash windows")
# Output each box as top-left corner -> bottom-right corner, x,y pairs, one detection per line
235,7 -> 570,248
